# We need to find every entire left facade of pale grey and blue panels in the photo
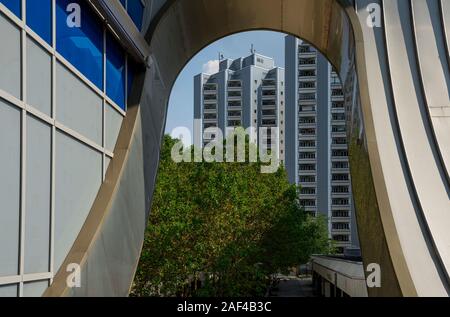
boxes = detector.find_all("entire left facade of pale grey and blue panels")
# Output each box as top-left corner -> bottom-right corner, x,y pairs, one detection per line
0,0 -> 142,296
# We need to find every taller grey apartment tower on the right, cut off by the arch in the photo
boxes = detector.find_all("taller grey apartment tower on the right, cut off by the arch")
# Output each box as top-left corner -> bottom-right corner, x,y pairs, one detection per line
285,36 -> 359,253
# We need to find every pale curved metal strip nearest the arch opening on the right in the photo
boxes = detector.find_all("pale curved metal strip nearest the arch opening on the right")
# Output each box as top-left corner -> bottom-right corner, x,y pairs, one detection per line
358,0 -> 426,294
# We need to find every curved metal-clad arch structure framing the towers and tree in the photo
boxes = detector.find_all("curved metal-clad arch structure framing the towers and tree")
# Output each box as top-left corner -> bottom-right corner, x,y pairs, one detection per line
0,0 -> 450,296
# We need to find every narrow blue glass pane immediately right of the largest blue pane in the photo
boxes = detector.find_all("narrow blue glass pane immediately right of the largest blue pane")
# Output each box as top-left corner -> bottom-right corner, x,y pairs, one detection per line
106,32 -> 125,109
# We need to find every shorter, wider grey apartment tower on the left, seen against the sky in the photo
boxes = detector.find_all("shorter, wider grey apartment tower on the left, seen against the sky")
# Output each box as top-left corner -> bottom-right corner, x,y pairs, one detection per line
194,53 -> 285,164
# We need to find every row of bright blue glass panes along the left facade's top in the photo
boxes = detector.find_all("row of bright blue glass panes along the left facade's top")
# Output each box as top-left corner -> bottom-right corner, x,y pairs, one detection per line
0,0 -> 137,110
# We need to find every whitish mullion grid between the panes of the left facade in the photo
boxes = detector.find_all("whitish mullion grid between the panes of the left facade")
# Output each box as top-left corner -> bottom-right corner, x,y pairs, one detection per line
0,0 -> 128,297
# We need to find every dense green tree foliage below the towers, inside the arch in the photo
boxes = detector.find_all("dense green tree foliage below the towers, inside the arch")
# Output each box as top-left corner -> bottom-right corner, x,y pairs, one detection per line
133,136 -> 330,297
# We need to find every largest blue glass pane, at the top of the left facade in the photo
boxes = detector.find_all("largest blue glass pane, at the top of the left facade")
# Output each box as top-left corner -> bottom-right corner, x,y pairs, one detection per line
56,0 -> 103,90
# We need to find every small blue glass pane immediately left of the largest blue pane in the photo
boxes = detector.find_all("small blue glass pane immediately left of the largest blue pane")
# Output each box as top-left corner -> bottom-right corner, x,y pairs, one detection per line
27,0 -> 52,45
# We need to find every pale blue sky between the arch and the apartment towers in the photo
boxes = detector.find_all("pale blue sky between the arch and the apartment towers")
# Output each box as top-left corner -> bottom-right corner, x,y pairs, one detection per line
166,31 -> 285,141
